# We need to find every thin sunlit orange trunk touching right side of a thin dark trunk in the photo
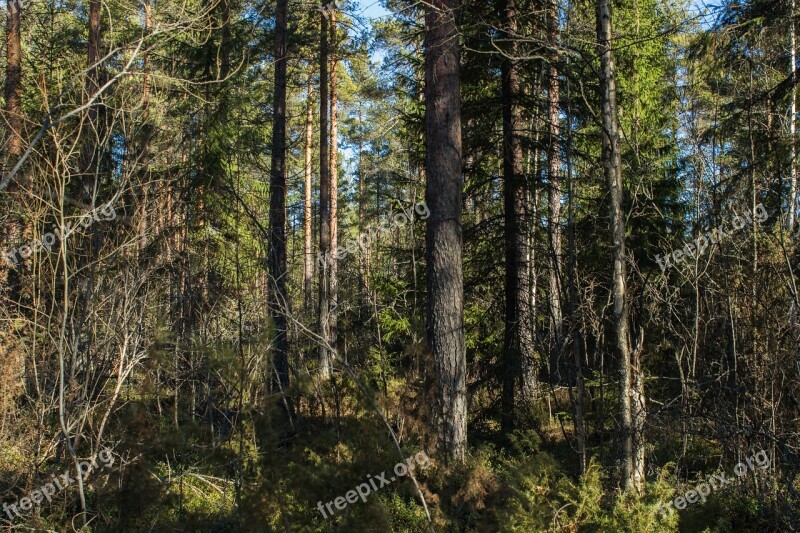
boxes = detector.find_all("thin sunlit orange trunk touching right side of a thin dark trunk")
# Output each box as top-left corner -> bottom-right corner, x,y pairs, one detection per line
328,9 -> 339,362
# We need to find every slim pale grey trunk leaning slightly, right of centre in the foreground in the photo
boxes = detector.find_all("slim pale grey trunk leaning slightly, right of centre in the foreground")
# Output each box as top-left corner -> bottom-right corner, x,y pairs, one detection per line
597,0 -> 644,490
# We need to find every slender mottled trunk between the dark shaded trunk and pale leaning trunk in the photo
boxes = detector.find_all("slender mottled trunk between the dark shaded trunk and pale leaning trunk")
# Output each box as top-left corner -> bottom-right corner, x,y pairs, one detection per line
547,0 -> 564,384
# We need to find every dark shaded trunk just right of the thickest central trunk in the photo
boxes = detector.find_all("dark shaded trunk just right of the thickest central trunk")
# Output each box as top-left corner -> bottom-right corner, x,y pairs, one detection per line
501,0 -> 533,432
